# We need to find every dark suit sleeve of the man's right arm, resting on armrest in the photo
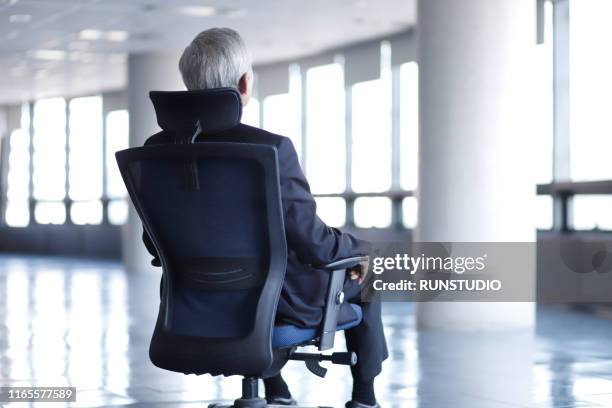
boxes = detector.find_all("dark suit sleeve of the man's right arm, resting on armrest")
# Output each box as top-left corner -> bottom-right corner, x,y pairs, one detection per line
277,138 -> 370,265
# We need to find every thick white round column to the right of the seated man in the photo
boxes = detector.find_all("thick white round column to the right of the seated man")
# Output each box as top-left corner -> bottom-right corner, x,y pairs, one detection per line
416,0 -> 536,331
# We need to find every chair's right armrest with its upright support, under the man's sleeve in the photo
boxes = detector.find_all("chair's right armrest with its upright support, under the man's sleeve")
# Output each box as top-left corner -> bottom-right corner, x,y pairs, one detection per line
317,256 -> 369,351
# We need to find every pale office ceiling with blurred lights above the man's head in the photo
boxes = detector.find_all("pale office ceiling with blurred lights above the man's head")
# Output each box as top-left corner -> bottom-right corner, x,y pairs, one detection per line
0,0 -> 415,104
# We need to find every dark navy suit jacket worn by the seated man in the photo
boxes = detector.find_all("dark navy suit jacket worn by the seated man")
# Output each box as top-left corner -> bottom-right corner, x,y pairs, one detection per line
143,92 -> 369,327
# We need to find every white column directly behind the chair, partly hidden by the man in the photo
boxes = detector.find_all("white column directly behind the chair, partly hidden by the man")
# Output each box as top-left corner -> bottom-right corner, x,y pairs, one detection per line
122,53 -> 185,272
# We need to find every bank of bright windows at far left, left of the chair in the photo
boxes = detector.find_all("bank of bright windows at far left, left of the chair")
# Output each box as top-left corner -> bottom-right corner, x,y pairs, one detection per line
4,96 -> 128,227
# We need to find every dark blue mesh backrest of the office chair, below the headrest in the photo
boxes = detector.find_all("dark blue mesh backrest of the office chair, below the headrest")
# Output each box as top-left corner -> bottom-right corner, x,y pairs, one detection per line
116,142 -> 287,375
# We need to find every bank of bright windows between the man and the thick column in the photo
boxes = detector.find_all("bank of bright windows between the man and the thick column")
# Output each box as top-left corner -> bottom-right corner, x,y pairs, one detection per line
248,45 -> 418,228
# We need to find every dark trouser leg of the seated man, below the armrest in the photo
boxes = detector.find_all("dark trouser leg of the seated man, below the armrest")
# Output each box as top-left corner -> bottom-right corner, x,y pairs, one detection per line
344,281 -> 389,382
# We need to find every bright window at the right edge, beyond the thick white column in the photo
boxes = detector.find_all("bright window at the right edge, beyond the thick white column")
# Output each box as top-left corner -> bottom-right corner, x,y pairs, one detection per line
527,0 -> 612,231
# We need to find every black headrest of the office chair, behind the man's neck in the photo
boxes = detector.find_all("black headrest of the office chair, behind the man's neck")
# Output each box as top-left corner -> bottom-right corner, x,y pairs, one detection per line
149,88 -> 242,134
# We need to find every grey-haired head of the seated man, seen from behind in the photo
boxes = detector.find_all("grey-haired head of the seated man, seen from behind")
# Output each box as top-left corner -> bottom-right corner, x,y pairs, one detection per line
179,28 -> 253,105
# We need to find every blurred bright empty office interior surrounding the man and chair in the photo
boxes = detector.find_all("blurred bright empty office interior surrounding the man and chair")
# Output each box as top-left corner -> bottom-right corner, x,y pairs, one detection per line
0,0 -> 612,408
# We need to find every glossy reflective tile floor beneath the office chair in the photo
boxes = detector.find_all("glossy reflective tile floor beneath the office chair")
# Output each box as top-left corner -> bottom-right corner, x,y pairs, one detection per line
0,256 -> 612,408
